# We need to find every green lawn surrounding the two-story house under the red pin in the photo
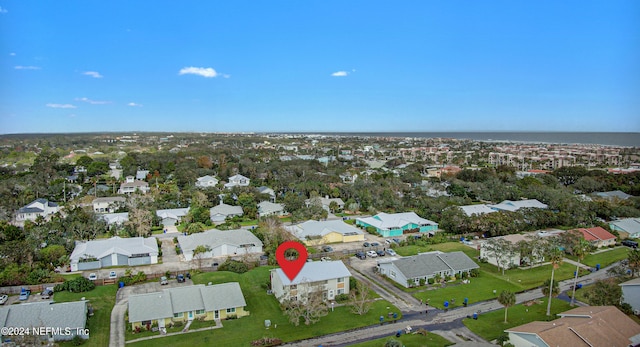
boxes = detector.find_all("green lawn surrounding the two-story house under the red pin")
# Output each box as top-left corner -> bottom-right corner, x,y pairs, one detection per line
133,267 -> 400,347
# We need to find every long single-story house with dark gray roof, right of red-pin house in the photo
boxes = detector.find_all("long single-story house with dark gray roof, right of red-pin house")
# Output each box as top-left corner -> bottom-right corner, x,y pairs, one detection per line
378,251 -> 480,288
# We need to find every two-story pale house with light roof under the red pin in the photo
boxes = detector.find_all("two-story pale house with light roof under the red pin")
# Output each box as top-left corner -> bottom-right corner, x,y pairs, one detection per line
271,260 -> 351,303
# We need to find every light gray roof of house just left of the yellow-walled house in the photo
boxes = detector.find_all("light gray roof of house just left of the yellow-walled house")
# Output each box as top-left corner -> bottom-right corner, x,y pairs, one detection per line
178,229 -> 262,252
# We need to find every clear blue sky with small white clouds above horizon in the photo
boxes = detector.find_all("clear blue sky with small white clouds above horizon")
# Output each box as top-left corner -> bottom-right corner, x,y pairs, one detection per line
0,0 -> 640,133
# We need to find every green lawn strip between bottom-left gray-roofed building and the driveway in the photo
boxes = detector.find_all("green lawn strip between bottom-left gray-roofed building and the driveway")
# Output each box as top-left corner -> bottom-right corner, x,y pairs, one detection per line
53,285 -> 118,346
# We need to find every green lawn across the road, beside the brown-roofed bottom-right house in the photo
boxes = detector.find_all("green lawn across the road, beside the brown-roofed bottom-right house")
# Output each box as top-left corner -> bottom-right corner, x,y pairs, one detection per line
462,299 -> 571,341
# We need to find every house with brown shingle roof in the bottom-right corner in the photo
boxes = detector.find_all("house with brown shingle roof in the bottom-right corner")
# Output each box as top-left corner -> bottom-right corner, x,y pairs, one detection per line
505,306 -> 640,347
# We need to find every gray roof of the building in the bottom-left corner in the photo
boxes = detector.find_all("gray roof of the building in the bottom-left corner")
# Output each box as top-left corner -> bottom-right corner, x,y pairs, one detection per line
0,301 -> 87,329
